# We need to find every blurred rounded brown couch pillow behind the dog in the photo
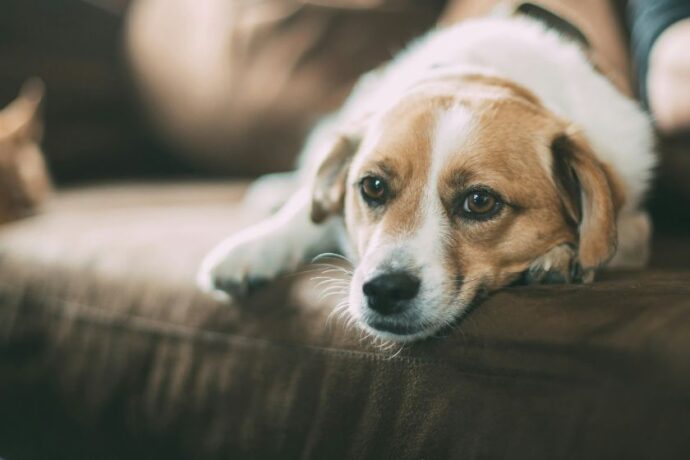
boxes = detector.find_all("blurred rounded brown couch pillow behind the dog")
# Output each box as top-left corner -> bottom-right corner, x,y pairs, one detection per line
128,0 -> 442,174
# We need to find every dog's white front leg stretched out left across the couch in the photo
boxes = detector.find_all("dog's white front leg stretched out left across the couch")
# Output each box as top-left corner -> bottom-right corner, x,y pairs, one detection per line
197,187 -> 339,298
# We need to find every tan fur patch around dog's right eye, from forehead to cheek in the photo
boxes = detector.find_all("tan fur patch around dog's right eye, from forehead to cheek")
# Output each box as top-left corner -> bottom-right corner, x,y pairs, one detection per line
430,94 -> 577,301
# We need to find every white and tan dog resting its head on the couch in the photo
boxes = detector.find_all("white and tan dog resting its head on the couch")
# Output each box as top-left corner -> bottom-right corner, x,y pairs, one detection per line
197,13 -> 656,342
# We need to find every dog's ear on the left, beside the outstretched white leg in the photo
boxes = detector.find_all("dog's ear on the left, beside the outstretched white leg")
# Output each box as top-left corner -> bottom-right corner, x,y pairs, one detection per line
311,134 -> 359,224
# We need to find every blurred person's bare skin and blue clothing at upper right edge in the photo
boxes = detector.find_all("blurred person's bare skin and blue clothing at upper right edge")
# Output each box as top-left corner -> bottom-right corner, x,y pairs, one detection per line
630,0 -> 690,134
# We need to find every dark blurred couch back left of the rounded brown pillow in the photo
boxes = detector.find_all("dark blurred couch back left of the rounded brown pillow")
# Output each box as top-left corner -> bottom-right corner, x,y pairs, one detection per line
0,0 -> 191,183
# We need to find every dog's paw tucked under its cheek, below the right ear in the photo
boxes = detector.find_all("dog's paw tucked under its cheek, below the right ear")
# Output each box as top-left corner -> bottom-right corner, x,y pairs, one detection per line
525,244 -> 582,284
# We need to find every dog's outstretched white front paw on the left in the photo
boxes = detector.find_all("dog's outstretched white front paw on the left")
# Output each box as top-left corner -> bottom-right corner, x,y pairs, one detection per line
197,235 -> 286,301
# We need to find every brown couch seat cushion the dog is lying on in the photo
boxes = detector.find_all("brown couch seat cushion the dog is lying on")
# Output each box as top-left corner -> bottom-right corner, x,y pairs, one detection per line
0,183 -> 690,459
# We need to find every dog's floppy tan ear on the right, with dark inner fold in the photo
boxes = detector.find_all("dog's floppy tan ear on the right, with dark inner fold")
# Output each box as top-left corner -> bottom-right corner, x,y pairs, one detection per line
551,128 -> 623,281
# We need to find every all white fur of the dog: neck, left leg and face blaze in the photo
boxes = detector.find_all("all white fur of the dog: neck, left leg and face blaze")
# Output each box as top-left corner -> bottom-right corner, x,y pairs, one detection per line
198,18 -> 655,339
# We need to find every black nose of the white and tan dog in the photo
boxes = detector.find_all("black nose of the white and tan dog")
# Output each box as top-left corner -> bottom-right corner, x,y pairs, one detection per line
362,272 -> 421,315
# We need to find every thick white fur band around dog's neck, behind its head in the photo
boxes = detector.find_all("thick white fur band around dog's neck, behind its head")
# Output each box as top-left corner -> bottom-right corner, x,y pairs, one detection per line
342,18 -> 656,209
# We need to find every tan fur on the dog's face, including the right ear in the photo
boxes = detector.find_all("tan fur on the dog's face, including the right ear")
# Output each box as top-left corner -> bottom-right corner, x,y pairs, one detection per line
318,75 -> 624,308
